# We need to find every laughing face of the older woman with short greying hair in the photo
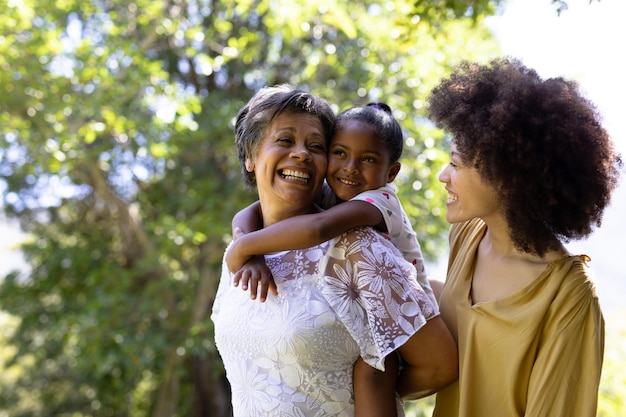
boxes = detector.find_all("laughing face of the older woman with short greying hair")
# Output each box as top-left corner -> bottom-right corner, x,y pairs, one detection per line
246,109 -> 327,226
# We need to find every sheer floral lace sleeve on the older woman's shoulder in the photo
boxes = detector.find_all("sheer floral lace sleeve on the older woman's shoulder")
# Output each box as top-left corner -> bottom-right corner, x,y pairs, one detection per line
322,228 -> 438,370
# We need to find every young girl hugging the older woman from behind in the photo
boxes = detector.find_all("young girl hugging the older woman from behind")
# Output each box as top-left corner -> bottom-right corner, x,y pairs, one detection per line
226,103 -> 437,417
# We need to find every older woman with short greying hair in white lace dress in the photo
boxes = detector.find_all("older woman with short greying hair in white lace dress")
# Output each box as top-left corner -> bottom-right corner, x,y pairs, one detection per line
212,86 -> 457,417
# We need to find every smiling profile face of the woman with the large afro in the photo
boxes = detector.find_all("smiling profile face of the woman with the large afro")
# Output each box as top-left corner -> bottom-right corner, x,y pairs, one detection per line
439,144 -> 501,223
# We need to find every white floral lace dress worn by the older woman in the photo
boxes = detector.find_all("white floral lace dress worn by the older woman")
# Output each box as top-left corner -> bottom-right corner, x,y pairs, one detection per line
211,228 -> 439,417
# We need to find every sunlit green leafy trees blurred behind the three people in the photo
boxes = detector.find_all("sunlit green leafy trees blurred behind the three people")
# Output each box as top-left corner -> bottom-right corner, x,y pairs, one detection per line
0,0 -> 499,417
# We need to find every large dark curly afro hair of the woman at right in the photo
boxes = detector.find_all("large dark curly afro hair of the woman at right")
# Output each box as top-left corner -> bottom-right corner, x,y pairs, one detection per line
428,57 -> 623,256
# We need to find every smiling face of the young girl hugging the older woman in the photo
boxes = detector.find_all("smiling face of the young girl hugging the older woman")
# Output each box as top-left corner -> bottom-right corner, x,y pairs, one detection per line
326,121 -> 400,201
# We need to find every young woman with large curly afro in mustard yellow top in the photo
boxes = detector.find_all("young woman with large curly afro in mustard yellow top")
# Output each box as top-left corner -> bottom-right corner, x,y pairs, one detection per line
429,58 -> 622,417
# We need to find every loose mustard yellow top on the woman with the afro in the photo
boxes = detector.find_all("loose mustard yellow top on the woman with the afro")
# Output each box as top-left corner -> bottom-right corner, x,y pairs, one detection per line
433,219 -> 604,417
